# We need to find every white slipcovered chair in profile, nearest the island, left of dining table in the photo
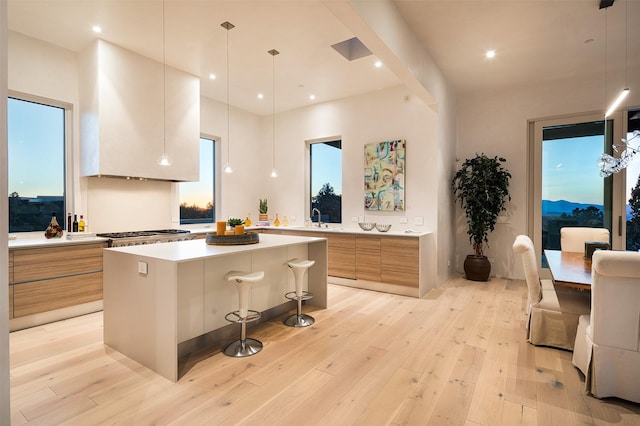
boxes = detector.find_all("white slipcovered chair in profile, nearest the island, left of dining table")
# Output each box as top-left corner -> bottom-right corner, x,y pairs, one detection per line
513,235 -> 591,350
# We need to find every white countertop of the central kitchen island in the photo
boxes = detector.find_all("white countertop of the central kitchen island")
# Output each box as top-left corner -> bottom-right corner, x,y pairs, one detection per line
105,231 -> 324,262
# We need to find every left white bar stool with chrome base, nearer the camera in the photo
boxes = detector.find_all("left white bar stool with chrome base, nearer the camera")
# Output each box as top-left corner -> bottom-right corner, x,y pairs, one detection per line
223,271 -> 264,358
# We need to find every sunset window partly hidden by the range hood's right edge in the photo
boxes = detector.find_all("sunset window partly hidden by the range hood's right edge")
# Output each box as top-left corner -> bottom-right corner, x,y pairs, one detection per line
180,138 -> 216,225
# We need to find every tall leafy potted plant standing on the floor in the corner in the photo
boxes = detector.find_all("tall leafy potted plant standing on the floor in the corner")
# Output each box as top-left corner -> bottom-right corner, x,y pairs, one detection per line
451,154 -> 511,281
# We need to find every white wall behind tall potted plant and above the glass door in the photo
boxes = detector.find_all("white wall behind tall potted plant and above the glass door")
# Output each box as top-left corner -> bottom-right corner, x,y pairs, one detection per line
456,69 -> 640,279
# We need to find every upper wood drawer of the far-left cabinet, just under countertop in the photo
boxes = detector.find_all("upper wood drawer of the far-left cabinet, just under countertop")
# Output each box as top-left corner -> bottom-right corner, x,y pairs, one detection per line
13,244 -> 106,283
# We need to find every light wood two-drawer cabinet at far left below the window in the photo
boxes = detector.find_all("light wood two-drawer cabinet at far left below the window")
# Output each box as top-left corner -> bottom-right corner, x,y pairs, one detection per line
9,242 -> 107,318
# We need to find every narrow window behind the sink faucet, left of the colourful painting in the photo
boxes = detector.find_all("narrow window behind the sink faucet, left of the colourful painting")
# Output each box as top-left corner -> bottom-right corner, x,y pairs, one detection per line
309,140 -> 342,223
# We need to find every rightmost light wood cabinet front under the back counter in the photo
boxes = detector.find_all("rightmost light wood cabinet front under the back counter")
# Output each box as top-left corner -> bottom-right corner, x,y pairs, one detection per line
380,237 -> 420,288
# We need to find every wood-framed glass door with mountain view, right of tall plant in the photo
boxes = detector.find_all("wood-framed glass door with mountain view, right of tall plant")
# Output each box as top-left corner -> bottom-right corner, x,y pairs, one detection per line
529,110 -> 623,268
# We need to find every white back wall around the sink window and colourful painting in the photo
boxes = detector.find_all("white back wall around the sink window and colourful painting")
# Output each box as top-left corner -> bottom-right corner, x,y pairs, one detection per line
262,87 -> 437,231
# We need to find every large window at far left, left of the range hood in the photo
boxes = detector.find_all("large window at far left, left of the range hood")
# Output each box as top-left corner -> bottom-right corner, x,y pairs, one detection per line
7,95 -> 71,232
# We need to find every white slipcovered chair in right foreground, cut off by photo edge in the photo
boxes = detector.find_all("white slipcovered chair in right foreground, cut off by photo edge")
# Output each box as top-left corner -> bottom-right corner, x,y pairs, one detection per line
573,251 -> 640,403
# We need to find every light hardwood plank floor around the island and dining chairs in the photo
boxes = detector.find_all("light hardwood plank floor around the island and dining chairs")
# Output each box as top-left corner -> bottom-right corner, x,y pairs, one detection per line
10,278 -> 640,426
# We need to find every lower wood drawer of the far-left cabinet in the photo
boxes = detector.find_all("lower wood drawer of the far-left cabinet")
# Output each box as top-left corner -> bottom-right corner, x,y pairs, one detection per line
12,272 -> 102,318
